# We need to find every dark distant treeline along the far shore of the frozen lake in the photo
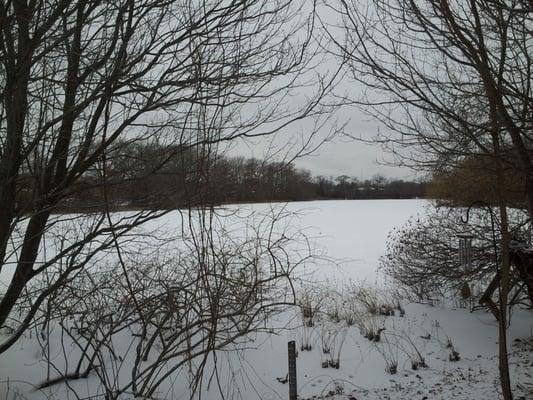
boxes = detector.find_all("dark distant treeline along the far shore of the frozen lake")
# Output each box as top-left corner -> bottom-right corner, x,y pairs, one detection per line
18,142 -> 426,210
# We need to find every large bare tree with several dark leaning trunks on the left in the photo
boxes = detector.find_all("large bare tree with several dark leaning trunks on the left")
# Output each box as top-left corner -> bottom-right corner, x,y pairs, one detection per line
0,0 -> 335,353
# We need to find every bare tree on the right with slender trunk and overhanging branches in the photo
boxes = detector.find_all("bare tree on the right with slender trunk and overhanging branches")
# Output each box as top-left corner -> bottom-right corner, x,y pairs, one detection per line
324,0 -> 533,399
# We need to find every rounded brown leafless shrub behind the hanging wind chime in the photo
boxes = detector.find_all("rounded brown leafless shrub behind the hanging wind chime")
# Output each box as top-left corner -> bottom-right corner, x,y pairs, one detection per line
380,207 -> 528,303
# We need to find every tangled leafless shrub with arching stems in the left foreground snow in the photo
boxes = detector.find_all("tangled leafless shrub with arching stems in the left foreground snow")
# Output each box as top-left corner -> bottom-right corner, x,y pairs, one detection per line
20,206 -> 312,399
